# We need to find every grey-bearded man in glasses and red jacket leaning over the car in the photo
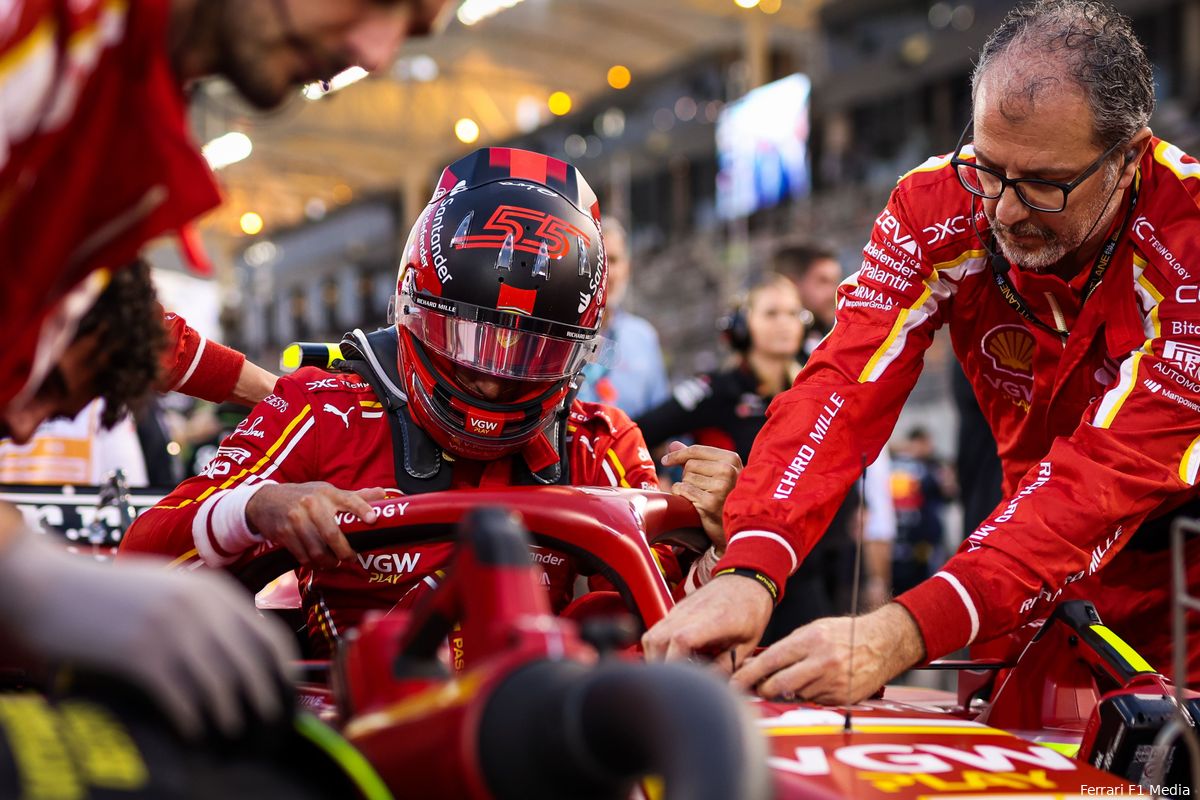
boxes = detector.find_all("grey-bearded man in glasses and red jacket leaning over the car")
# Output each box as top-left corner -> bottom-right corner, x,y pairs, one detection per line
643,0 -> 1200,703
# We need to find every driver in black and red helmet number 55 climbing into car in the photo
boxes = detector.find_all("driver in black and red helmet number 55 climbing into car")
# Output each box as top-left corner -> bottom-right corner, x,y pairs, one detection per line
121,148 -> 742,654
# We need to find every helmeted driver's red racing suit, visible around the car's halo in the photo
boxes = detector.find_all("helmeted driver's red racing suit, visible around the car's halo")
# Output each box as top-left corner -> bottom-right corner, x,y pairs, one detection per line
121,367 -> 679,651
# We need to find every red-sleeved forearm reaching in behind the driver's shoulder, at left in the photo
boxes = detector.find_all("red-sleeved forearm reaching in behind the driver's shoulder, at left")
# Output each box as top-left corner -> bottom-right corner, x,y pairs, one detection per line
158,312 -> 275,405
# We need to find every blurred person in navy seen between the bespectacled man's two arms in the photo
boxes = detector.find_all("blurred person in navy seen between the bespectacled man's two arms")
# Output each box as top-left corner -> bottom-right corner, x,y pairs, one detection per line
892,427 -> 955,594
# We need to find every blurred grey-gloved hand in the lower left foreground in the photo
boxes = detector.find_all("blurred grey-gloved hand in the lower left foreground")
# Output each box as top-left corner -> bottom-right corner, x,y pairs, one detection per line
0,533 -> 298,738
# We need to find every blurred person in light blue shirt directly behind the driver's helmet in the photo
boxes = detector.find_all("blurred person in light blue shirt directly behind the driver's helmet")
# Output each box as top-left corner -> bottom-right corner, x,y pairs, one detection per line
580,217 -> 671,417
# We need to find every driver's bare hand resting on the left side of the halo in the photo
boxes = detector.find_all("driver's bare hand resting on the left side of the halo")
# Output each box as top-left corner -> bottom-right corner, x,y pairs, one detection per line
246,481 -> 386,567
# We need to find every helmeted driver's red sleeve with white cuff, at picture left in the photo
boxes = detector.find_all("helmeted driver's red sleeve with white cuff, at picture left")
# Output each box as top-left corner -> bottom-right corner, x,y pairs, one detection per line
120,378 -> 317,566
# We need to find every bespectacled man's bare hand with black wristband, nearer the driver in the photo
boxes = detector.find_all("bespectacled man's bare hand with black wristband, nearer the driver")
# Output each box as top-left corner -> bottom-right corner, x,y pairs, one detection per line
642,575 -> 775,672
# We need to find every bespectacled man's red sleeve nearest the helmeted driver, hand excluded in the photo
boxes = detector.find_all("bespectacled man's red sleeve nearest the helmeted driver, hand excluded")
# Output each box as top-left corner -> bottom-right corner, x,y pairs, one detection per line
716,181 -> 964,589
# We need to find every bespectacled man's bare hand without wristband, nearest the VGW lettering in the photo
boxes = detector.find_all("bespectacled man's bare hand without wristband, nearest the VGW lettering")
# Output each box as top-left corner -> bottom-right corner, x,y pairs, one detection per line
733,603 -> 925,705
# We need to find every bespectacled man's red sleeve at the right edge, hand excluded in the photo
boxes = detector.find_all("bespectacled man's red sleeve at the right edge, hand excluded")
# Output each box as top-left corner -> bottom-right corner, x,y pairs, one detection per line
898,250 -> 1200,658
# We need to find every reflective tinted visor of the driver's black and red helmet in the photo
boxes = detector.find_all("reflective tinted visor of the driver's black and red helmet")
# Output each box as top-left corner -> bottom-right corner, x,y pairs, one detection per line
396,303 -> 601,380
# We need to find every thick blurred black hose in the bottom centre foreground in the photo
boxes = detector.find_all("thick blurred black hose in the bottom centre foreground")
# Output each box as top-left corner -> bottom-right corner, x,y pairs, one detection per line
479,661 -> 769,800
